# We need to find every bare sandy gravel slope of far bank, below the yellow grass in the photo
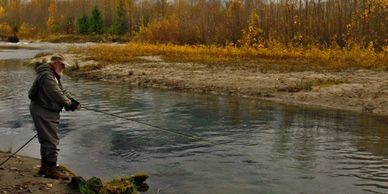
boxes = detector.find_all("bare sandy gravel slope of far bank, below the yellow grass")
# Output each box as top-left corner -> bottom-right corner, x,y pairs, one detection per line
73,61 -> 388,115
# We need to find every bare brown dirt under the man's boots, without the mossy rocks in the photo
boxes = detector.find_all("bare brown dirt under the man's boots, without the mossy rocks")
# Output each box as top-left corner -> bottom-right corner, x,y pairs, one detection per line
0,152 -> 79,194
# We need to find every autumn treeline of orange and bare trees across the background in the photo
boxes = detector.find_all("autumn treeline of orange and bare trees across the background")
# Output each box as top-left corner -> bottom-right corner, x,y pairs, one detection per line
0,0 -> 388,49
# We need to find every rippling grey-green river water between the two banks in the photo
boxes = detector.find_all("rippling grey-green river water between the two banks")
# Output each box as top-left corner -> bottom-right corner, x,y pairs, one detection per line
0,42 -> 388,194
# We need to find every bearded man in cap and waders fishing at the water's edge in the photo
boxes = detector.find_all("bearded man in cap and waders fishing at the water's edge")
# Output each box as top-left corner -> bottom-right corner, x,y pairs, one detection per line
28,55 -> 81,180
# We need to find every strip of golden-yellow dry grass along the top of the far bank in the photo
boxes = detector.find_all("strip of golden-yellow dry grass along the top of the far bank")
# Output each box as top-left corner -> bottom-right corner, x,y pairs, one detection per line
73,43 -> 388,71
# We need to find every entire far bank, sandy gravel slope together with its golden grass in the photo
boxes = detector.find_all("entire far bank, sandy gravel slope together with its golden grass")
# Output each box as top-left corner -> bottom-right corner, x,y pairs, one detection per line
29,43 -> 388,116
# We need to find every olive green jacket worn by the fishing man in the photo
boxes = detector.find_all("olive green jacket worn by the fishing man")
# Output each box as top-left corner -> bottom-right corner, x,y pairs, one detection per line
28,63 -> 71,112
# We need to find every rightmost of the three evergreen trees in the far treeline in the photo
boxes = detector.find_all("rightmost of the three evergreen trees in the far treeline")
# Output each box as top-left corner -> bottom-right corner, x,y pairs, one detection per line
112,0 -> 128,35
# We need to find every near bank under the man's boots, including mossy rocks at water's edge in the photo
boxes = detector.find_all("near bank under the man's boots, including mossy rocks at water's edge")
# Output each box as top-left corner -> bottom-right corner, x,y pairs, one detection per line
0,151 -> 148,194
